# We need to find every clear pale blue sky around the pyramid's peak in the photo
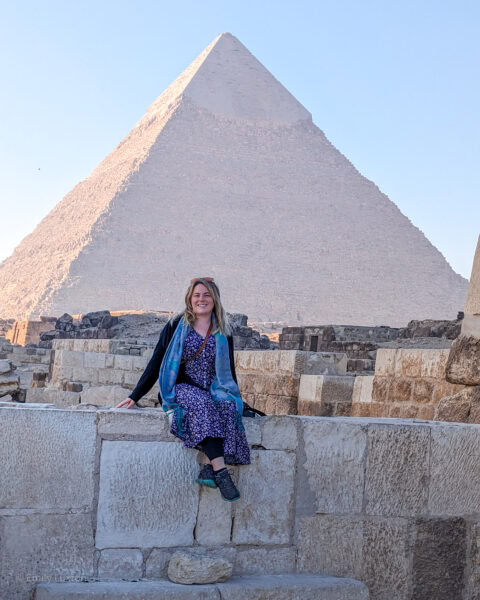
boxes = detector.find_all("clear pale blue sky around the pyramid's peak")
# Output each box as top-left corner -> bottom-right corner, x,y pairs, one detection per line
0,0 -> 480,278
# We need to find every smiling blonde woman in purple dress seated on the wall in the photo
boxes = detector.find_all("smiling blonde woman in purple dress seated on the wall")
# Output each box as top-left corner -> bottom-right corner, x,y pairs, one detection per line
115,277 -> 250,502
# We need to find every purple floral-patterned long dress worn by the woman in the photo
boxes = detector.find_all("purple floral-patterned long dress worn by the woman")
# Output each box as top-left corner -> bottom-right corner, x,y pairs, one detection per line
170,327 -> 250,465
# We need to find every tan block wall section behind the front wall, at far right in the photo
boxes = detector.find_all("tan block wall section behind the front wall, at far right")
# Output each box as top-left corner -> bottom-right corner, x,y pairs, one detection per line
352,348 -> 466,422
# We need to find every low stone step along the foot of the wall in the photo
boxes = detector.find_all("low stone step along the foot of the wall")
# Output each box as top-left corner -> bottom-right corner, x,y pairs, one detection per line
34,574 -> 369,600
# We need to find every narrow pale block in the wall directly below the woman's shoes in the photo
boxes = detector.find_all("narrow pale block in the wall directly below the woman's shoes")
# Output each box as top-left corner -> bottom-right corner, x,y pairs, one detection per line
195,486 -> 232,548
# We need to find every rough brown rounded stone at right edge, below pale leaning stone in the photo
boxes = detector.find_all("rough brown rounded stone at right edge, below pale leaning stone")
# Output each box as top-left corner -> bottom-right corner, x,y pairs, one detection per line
446,334 -> 480,385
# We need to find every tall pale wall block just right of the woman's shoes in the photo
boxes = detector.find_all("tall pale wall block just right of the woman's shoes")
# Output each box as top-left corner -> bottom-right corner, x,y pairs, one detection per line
232,450 -> 295,545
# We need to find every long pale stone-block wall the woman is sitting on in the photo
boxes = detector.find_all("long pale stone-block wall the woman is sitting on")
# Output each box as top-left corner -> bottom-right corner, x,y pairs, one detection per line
0,408 -> 480,600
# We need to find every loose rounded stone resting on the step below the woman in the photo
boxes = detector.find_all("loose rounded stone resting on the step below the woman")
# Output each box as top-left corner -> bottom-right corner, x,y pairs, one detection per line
167,551 -> 233,585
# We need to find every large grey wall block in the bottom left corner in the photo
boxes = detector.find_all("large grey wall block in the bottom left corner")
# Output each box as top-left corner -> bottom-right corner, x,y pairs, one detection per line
0,510 -> 94,600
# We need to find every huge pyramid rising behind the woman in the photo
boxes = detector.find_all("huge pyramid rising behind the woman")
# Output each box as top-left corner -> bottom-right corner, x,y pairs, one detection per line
0,33 -> 467,325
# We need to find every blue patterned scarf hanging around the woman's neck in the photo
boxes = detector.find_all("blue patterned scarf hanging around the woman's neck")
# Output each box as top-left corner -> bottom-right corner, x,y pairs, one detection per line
158,312 -> 244,437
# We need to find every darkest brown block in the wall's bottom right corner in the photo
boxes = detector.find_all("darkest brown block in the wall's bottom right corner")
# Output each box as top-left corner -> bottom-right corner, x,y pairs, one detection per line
412,518 -> 466,600
